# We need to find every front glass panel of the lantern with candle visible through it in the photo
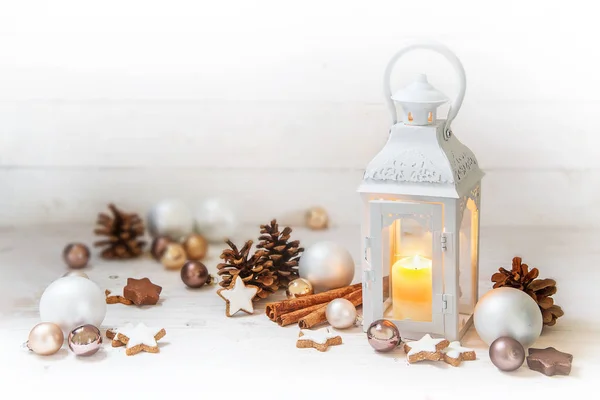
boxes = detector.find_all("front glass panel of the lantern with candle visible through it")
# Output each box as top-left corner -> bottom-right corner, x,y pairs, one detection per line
383,214 -> 433,322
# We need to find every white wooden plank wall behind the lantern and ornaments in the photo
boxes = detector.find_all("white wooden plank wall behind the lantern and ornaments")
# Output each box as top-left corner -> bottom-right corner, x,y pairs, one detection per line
0,0 -> 600,227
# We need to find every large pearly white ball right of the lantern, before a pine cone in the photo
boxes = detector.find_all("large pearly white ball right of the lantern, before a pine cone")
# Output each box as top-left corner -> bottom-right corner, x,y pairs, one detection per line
473,287 -> 543,348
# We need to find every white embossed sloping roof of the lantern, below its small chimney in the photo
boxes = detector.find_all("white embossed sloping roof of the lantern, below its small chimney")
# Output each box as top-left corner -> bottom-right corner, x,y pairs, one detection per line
358,120 -> 483,198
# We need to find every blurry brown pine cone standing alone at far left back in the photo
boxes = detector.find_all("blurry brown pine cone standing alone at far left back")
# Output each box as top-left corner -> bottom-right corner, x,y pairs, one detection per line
94,204 -> 146,259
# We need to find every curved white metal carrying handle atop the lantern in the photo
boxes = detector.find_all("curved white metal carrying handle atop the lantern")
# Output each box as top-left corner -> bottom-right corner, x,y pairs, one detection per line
383,42 -> 467,138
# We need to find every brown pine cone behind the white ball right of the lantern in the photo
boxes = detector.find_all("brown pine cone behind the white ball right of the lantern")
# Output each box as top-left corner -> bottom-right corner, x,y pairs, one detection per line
492,257 -> 564,326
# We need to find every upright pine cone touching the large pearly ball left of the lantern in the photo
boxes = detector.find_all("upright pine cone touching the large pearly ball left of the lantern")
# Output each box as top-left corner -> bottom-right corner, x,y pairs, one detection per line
256,219 -> 304,287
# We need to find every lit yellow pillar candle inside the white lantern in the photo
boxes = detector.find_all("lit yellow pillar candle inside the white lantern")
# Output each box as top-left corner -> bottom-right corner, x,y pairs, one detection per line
392,255 -> 432,321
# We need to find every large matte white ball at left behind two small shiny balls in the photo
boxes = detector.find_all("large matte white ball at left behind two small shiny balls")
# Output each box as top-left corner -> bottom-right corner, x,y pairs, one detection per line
40,276 -> 106,337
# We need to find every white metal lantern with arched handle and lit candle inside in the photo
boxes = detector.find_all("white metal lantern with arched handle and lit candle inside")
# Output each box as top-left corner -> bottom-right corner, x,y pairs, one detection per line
359,43 -> 483,340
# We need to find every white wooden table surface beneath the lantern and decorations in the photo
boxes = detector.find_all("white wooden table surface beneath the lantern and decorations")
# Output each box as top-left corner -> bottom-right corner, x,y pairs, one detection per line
0,225 -> 600,400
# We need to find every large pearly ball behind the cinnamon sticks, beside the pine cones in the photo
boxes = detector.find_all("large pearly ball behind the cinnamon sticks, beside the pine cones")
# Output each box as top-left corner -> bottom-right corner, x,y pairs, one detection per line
298,241 -> 354,292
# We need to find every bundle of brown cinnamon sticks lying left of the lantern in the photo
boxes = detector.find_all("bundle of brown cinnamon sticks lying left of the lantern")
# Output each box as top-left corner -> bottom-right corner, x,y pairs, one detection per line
266,283 -> 362,329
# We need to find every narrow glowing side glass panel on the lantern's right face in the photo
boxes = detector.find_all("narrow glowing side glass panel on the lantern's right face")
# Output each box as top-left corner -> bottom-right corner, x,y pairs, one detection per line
458,199 -> 479,319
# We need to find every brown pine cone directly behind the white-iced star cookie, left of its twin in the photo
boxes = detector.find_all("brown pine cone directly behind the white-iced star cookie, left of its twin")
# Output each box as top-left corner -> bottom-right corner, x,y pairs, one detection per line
217,240 -> 279,300
